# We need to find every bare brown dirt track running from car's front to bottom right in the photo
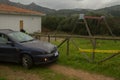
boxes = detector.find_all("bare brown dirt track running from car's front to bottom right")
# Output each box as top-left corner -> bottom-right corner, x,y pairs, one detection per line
50,65 -> 115,80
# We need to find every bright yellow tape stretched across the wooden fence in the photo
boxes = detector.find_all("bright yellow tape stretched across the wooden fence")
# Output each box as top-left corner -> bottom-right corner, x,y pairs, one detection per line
79,48 -> 120,53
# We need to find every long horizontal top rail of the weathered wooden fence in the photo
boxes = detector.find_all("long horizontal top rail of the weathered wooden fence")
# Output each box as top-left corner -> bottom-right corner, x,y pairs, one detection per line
32,34 -> 120,42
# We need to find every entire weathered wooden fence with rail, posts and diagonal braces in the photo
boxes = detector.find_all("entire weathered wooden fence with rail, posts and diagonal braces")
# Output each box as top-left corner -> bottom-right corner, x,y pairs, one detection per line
32,34 -> 120,63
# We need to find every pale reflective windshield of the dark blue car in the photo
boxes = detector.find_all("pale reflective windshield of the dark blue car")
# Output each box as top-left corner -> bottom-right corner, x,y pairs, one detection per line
8,32 -> 34,43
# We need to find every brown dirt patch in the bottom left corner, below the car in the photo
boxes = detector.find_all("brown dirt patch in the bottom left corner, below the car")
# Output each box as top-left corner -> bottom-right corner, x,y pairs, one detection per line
0,65 -> 41,80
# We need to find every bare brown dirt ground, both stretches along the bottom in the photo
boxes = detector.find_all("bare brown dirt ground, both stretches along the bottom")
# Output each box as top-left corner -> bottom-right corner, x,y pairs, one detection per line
0,65 -> 115,80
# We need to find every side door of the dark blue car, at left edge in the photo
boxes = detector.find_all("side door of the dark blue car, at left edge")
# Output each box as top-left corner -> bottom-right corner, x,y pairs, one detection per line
0,34 -> 18,62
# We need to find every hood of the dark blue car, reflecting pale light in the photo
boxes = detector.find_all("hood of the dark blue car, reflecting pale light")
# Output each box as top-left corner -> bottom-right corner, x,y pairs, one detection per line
22,40 -> 56,53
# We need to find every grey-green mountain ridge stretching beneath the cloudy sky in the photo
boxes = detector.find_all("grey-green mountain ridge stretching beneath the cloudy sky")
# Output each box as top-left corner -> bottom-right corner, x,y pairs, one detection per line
0,0 -> 120,17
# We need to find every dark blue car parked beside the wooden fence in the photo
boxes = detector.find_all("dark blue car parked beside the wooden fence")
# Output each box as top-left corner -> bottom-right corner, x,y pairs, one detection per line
0,29 -> 59,68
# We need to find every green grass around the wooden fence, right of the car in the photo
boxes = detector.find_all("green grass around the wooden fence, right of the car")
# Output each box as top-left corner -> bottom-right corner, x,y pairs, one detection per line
52,39 -> 120,80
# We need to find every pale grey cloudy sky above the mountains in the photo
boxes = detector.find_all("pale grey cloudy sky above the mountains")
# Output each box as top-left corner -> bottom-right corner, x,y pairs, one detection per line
10,0 -> 120,9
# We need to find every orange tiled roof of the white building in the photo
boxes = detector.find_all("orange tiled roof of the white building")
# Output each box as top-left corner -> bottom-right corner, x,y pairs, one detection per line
0,4 -> 44,16
